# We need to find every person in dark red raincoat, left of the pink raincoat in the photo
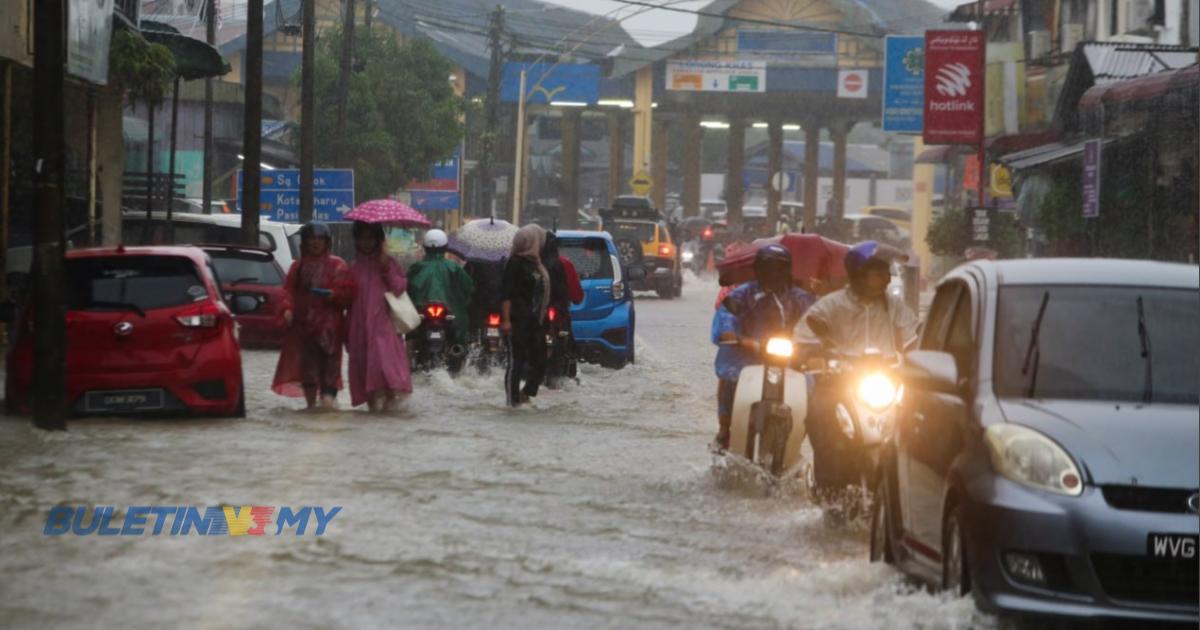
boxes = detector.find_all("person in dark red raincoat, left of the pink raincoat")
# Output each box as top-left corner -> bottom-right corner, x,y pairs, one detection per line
271,222 -> 355,409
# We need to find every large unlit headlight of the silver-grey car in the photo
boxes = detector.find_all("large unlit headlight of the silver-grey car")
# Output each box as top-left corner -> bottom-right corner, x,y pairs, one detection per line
984,424 -> 1084,497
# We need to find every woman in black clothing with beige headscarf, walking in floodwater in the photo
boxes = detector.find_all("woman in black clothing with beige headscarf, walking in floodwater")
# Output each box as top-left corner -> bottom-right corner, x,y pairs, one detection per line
500,226 -> 551,407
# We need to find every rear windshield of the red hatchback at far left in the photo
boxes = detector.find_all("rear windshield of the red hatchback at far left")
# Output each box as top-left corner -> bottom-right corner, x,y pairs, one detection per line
67,256 -> 209,311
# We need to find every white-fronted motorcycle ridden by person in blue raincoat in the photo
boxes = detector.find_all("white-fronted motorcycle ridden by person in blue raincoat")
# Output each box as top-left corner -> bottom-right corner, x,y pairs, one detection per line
722,336 -> 808,479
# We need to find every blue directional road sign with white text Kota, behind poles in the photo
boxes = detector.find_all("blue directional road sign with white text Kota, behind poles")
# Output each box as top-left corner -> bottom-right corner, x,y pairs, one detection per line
238,168 -> 354,223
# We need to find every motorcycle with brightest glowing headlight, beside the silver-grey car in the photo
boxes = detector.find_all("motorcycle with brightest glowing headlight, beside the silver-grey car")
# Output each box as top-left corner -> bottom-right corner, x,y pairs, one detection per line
811,348 -> 904,509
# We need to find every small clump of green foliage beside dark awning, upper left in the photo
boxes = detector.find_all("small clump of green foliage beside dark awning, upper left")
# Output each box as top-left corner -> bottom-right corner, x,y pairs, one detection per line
108,29 -> 175,107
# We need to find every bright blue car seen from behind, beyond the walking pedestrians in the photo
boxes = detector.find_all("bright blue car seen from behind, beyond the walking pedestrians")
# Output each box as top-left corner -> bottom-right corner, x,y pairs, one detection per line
557,230 -> 646,368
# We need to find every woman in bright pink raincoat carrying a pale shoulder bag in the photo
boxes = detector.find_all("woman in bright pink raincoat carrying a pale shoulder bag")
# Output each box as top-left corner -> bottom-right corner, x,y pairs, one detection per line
347,221 -> 413,413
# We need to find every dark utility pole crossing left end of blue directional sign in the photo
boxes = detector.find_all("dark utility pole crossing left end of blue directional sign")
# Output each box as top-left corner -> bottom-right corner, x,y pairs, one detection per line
241,0 -> 264,247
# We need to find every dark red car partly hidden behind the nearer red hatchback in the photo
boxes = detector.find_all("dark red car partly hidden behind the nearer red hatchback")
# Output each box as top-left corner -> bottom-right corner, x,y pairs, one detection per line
200,245 -> 287,348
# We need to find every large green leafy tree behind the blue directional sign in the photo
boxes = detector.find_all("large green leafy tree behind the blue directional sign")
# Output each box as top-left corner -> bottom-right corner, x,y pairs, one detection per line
293,29 -> 463,200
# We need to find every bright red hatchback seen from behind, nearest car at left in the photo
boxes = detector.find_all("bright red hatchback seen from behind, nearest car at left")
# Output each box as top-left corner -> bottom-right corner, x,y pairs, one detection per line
6,247 -> 246,416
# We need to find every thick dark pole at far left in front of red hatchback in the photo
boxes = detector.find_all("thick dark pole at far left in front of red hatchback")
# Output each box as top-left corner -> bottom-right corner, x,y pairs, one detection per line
34,0 -> 67,431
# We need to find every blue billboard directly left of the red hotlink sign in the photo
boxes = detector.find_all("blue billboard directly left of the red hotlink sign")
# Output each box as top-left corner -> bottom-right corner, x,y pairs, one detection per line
883,35 -> 925,133
